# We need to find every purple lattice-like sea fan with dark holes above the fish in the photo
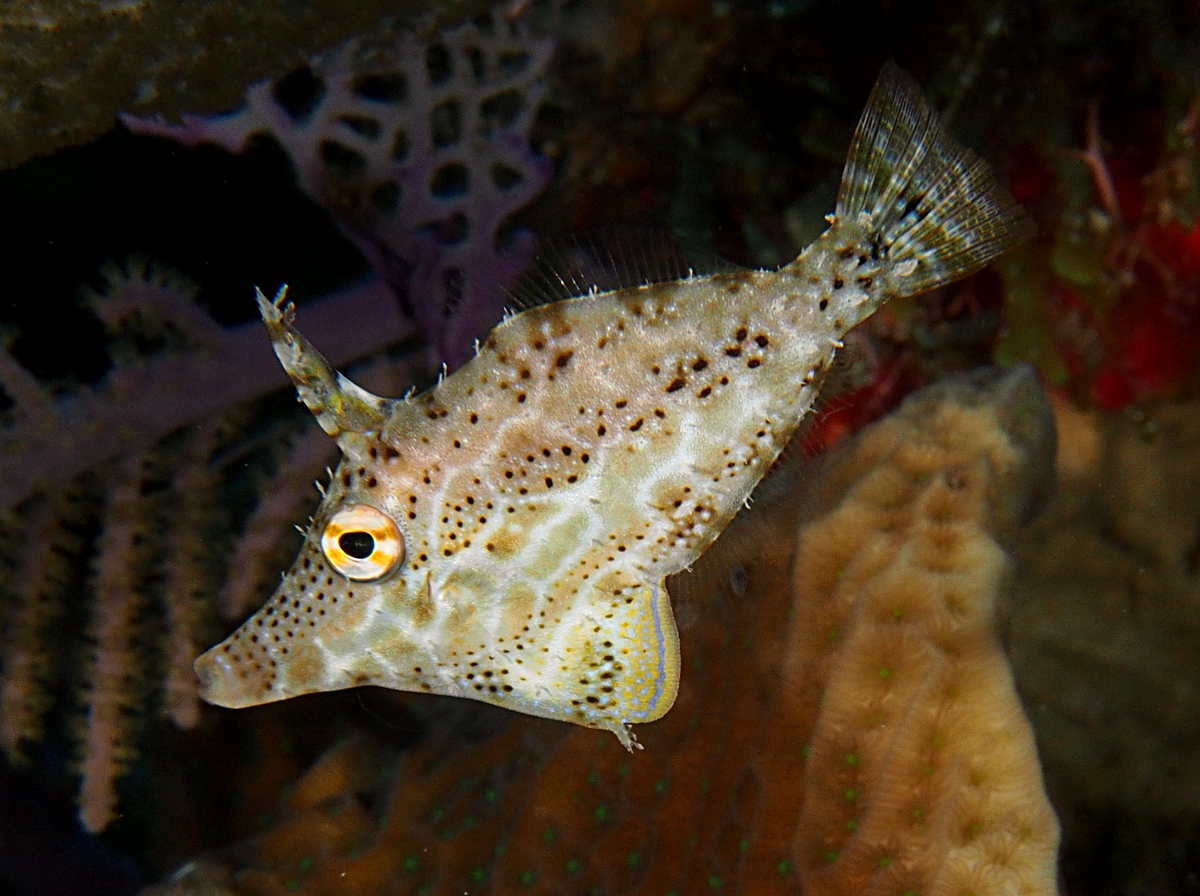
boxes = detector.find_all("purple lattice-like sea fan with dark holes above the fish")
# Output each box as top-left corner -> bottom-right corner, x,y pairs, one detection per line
122,12 -> 553,368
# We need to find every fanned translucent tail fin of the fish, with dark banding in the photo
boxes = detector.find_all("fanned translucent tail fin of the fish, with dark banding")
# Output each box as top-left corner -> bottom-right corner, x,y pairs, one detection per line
836,61 -> 1036,295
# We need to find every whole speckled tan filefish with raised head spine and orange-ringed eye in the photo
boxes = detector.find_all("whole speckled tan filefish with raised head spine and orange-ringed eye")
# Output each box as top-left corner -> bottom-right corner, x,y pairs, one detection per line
196,65 -> 1032,746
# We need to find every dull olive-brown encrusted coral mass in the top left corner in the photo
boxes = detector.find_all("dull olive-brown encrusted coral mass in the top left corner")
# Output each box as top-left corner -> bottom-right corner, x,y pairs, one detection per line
0,0 -> 484,167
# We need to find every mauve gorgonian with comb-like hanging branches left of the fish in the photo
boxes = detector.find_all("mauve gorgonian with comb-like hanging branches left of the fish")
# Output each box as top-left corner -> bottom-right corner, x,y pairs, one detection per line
0,261 -> 424,831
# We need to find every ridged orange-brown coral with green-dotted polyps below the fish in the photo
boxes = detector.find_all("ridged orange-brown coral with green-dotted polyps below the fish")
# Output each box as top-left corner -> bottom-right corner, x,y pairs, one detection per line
142,368 -> 1057,894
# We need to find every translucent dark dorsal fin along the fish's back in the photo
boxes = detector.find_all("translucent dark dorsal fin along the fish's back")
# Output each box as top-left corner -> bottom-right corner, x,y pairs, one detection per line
509,227 -> 737,311
